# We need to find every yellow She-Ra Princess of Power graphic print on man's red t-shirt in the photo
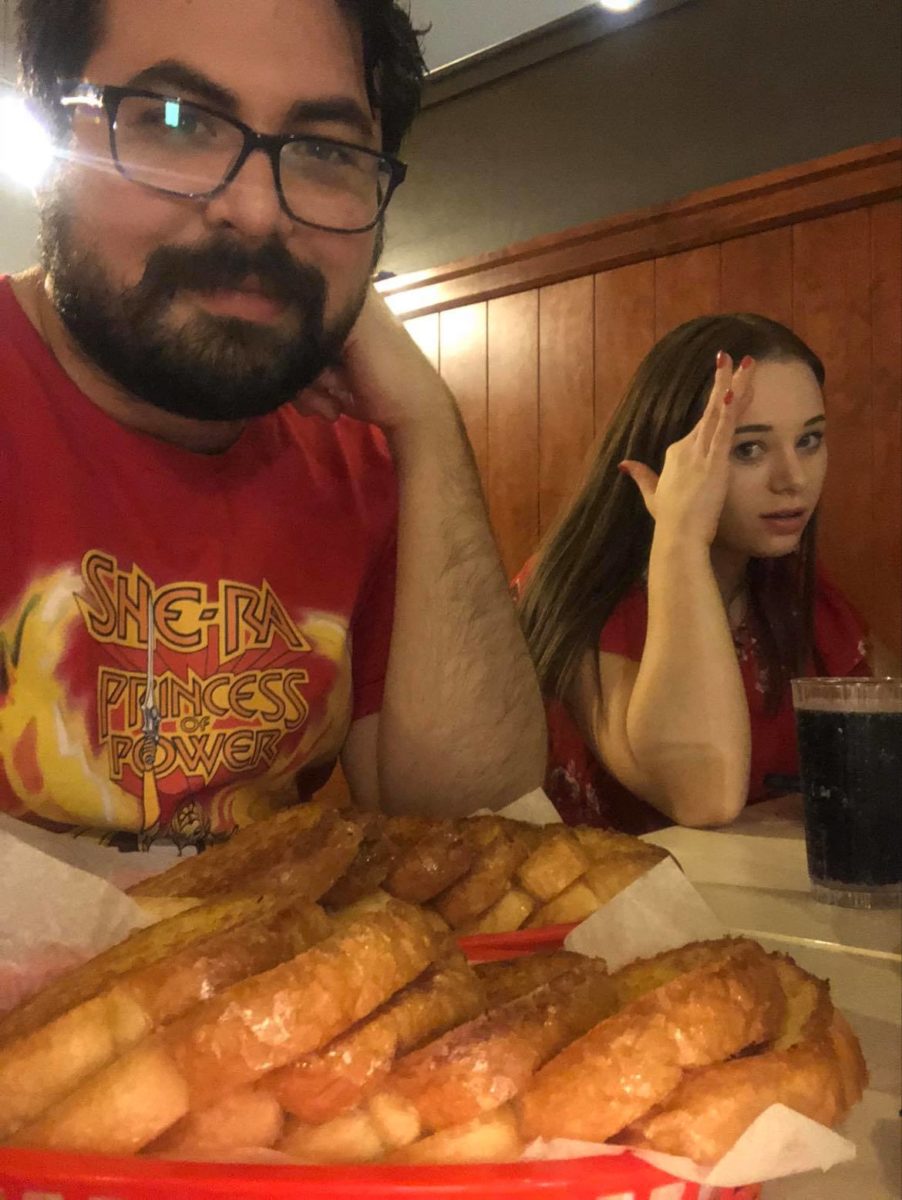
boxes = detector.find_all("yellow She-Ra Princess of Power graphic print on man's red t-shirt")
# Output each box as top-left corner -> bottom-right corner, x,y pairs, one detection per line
0,550 -> 350,845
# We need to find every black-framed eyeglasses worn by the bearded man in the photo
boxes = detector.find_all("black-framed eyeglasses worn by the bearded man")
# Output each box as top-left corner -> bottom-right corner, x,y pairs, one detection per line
59,84 -> 407,233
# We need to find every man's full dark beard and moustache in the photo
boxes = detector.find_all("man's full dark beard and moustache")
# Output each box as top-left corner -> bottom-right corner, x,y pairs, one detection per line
41,193 -> 367,421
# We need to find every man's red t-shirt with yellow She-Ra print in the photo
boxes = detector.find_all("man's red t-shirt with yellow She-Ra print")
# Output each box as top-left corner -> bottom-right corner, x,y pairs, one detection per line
0,278 -> 397,844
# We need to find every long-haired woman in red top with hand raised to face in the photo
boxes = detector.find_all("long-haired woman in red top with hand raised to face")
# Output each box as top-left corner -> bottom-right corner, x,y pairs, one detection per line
515,313 -> 887,832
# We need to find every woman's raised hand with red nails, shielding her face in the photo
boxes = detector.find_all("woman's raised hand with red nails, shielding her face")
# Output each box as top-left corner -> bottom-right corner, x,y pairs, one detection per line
620,352 -> 754,546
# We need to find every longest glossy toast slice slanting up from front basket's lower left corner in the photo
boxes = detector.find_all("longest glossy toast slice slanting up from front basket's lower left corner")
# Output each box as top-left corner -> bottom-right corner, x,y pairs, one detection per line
13,901 -> 445,1153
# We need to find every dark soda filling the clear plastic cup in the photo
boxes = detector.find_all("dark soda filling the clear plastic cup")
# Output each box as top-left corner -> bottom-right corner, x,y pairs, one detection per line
796,710 -> 902,888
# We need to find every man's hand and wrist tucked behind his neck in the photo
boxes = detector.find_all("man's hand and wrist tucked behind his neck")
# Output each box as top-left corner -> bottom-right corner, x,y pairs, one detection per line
295,288 -> 453,433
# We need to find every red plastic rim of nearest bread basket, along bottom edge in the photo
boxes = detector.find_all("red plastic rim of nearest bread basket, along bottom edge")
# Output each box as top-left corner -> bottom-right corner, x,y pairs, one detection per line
0,1150 -> 760,1200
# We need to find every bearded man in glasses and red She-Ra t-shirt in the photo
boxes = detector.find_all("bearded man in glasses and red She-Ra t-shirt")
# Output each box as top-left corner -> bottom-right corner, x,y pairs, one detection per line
0,0 -> 545,846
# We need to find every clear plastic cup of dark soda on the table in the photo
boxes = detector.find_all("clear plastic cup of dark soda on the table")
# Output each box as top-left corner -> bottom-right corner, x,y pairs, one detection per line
793,679 -> 902,908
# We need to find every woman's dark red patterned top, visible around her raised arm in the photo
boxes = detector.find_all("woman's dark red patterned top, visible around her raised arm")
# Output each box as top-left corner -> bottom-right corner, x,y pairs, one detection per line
517,565 -> 867,833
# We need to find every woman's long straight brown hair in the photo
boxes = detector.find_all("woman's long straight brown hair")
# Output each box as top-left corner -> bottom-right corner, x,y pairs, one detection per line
521,313 -> 824,712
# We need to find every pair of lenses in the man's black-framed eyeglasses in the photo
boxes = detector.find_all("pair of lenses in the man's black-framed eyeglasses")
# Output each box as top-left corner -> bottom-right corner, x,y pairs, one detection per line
114,96 -> 391,229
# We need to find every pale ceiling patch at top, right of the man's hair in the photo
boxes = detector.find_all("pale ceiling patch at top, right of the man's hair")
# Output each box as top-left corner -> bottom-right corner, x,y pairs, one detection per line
409,0 -> 588,71
